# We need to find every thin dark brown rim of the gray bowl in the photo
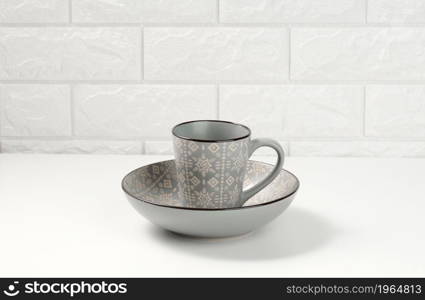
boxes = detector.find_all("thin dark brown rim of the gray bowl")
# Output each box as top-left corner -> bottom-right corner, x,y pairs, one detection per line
121,159 -> 300,211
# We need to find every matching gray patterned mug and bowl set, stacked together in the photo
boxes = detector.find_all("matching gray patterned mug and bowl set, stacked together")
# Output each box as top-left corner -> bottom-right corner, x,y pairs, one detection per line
122,120 -> 299,238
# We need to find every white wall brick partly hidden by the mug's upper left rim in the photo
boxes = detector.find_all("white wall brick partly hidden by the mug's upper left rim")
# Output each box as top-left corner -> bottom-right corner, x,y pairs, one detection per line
74,85 -> 217,139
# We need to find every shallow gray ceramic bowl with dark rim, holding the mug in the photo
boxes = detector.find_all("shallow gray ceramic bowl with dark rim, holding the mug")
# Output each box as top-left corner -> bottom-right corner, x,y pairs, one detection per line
122,160 -> 299,238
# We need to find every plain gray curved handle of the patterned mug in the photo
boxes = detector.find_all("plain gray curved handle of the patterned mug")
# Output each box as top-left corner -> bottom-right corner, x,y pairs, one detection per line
238,138 -> 285,206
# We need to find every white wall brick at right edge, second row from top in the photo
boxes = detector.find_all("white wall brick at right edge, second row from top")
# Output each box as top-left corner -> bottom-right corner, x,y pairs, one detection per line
291,27 -> 425,80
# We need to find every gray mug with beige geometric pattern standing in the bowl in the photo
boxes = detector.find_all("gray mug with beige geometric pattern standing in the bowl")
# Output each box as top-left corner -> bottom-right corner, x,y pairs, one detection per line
172,120 -> 284,209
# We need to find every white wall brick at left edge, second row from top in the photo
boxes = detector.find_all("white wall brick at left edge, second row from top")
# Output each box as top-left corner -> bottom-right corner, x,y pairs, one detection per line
0,27 -> 141,80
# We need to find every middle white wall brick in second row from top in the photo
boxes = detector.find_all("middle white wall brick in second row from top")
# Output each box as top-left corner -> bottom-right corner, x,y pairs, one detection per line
144,27 -> 289,81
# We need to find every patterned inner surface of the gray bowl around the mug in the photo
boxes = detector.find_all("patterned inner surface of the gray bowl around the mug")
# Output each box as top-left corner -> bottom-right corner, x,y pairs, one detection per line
122,160 -> 299,207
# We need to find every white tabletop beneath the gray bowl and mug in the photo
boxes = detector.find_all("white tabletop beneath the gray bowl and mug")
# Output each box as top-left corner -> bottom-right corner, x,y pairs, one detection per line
0,154 -> 425,277
